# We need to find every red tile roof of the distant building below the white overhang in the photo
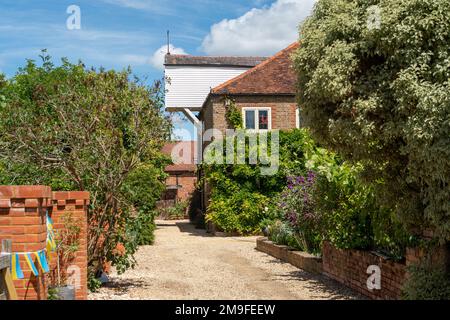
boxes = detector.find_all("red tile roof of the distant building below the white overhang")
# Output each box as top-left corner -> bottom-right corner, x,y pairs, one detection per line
161,141 -> 197,172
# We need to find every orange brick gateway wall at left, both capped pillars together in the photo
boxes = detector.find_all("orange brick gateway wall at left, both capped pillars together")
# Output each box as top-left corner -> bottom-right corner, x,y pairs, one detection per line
0,186 -> 89,300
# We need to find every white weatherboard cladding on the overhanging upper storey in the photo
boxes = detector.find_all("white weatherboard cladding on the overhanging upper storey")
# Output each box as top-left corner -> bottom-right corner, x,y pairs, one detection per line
165,66 -> 250,111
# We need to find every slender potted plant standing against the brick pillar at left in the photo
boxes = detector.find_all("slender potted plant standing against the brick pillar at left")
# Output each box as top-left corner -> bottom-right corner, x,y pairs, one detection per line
48,212 -> 81,300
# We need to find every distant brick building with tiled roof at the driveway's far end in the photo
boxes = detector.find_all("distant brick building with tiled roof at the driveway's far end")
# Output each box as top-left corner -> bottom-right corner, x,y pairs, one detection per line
160,141 -> 197,205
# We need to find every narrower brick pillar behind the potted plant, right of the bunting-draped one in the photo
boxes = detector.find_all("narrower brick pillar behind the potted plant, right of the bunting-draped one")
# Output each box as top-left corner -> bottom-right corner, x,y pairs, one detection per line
51,191 -> 90,300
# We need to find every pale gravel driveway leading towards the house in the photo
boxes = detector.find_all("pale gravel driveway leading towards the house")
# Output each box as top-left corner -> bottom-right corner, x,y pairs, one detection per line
89,221 -> 360,300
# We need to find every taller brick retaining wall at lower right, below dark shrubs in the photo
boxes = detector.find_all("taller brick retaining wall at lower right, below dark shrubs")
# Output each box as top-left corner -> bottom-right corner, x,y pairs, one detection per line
323,243 -> 406,300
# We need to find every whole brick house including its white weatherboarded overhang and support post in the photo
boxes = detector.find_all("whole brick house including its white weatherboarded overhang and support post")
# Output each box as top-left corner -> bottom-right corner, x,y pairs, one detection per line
165,43 -> 301,218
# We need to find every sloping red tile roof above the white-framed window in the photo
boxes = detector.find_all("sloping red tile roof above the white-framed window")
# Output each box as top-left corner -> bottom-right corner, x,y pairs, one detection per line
211,42 -> 299,95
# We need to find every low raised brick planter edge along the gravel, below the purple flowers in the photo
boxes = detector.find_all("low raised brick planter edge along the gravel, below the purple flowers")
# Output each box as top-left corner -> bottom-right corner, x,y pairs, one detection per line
256,238 -> 322,274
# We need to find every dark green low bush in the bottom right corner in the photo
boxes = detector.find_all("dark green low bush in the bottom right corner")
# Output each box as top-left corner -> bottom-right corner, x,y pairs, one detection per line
402,261 -> 450,300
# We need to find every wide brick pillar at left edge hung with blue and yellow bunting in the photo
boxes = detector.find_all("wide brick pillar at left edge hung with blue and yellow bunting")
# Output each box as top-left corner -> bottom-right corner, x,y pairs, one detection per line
0,186 -> 52,300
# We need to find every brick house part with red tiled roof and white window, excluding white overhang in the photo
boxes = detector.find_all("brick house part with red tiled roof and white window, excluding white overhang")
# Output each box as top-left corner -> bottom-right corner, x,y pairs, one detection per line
199,43 -> 300,136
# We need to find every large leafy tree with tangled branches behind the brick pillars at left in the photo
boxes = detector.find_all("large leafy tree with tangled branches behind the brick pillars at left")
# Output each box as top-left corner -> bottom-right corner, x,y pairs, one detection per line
0,54 -> 171,273
